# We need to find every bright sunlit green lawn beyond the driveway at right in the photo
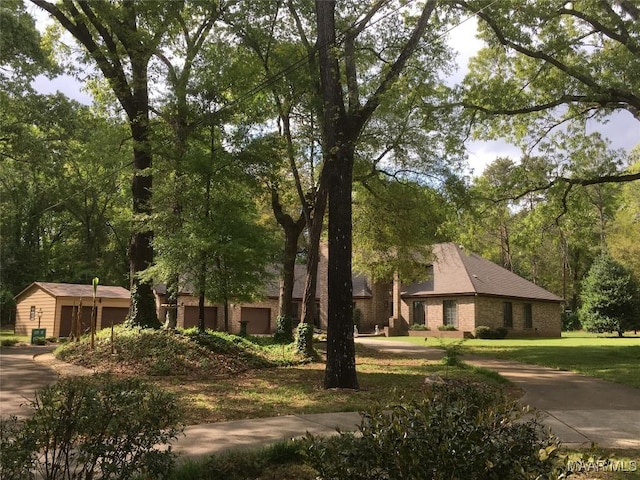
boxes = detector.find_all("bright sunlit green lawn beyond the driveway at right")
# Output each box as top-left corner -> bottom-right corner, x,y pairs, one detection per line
380,332 -> 640,388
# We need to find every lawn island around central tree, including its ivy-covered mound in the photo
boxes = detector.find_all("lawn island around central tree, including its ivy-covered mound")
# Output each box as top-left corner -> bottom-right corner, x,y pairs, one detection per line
55,327 -> 521,424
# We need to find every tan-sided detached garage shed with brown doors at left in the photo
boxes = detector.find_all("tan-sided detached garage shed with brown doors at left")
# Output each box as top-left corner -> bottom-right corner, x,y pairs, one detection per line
15,282 -> 131,337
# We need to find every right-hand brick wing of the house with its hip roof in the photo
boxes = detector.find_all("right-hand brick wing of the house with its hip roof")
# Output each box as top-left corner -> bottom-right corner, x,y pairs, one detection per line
389,243 -> 563,337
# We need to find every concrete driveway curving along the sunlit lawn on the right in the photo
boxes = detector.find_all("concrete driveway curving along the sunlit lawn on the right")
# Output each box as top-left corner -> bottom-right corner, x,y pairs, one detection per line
356,337 -> 640,448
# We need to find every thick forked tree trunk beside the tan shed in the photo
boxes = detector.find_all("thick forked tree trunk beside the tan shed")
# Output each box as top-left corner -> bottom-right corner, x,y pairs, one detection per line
31,0 -> 169,328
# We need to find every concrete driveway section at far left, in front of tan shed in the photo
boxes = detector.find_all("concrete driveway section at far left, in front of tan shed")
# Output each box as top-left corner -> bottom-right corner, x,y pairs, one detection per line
0,346 -> 58,417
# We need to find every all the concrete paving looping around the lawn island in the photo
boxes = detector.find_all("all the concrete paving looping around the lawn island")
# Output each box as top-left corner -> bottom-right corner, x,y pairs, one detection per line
0,337 -> 640,456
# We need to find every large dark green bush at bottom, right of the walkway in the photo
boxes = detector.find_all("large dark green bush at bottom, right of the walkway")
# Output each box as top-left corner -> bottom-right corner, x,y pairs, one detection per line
307,380 -> 562,480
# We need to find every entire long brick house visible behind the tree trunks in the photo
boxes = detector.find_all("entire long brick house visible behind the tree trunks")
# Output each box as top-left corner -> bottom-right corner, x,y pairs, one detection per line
155,243 -> 562,337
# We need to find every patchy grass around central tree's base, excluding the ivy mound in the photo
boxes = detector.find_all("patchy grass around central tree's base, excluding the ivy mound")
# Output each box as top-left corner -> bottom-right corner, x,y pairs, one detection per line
152,345 -> 510,424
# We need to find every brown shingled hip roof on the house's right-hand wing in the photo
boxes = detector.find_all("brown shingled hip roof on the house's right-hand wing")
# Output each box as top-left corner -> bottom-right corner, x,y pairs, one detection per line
402,243 -> 562,302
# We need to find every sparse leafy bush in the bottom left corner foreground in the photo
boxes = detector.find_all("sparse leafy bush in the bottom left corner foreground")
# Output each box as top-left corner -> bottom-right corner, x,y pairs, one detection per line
0,375 -> 181,480
